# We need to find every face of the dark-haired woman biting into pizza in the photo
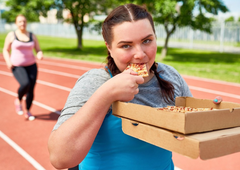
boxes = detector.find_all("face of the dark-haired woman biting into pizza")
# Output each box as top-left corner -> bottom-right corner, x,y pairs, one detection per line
106,19 -> 157,73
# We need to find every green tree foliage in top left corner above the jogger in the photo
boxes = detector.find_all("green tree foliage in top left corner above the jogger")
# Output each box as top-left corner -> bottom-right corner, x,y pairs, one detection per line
2,0 -> 54,22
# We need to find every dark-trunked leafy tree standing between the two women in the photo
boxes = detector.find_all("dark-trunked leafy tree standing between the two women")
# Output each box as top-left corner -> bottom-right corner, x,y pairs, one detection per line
56,0 -> 118,49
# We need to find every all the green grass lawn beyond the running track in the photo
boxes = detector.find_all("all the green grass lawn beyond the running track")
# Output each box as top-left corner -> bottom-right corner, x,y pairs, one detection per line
0,34 -> 240,83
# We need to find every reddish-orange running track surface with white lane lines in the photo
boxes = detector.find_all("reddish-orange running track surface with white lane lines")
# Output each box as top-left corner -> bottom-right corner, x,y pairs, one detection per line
0,55 -> 240,170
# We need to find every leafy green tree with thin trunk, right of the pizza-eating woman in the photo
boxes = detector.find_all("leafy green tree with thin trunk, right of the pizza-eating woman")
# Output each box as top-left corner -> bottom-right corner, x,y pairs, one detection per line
137,0 -> 228,59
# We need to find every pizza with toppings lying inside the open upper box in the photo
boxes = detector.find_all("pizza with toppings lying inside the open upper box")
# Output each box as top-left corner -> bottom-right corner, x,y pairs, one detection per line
158,106 -> 215,113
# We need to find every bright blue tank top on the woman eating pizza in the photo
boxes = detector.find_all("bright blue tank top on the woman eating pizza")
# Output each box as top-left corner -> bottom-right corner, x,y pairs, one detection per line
79,67 -> 174,170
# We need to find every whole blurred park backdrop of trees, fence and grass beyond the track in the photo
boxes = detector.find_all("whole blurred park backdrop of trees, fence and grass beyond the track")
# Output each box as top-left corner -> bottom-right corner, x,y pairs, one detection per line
0,0 -> 240,83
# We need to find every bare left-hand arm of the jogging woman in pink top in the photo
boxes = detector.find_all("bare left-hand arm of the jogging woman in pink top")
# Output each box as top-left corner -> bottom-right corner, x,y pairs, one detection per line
3,32 -> 14,69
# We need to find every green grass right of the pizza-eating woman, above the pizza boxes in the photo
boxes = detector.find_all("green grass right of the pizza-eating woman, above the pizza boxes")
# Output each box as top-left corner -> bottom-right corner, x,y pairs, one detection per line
159,48 -> 240,83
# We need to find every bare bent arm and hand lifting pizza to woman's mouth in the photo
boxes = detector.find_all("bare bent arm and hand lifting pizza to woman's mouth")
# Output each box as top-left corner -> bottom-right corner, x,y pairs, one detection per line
48,71 -> 144,169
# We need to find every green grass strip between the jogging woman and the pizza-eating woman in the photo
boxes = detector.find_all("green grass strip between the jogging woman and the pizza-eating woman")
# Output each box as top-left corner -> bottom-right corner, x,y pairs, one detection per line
38,36 -> 107,62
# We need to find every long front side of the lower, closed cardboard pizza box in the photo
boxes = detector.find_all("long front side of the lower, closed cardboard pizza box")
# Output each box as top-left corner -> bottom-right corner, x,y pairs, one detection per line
122,118 -> 199,159
